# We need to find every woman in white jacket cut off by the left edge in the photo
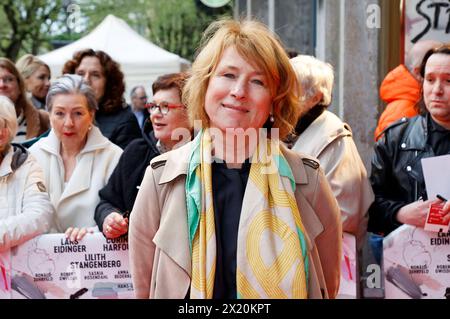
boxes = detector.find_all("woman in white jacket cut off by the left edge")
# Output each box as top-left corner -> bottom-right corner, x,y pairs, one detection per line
0,96 -> 53,252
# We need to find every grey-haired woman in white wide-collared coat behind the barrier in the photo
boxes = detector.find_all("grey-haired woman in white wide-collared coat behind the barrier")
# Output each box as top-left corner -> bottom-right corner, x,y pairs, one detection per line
30,74 -> 122,241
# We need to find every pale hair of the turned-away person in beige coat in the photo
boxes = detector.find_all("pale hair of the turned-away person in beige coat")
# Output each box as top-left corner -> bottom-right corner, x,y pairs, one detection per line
291,55 -> 334,106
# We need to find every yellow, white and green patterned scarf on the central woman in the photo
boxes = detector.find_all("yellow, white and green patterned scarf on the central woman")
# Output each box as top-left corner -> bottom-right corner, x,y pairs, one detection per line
186,130 -> 308,299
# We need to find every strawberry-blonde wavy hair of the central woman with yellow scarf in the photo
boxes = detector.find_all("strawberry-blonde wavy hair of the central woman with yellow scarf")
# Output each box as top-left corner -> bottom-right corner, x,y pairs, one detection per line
183,19 -> 300,139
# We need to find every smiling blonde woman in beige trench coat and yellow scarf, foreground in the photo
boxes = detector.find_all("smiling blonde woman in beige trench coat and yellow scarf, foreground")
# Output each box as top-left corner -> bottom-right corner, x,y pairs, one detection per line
129,20 -> 342,299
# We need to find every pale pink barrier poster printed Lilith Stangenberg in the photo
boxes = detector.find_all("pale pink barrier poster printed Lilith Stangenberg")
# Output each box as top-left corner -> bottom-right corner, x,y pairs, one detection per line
0,233 -> 134,299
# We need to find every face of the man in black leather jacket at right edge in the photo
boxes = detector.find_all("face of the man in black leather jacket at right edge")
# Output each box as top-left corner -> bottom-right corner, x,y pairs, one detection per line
423,53 -> 450,129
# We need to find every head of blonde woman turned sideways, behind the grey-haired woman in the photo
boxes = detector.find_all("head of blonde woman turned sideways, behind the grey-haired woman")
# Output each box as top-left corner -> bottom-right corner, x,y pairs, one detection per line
16,54 -> 51,110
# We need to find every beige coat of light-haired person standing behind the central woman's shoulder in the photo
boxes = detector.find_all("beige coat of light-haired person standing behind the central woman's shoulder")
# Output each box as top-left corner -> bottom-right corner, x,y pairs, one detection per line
292,111 -> 374,248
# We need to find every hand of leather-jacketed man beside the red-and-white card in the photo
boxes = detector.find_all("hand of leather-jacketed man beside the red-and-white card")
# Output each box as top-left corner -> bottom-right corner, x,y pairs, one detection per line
397,199 -> 442,228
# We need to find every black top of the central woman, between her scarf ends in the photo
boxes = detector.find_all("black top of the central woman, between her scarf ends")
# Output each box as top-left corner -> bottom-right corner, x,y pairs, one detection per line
212,160 -> 250,299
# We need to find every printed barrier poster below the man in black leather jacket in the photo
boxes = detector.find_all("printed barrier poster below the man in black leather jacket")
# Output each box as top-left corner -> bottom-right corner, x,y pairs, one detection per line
383,225 -> 450,299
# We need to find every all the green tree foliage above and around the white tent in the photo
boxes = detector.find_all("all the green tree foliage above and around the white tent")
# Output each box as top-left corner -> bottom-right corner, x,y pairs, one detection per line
0,0 -> 232,60
